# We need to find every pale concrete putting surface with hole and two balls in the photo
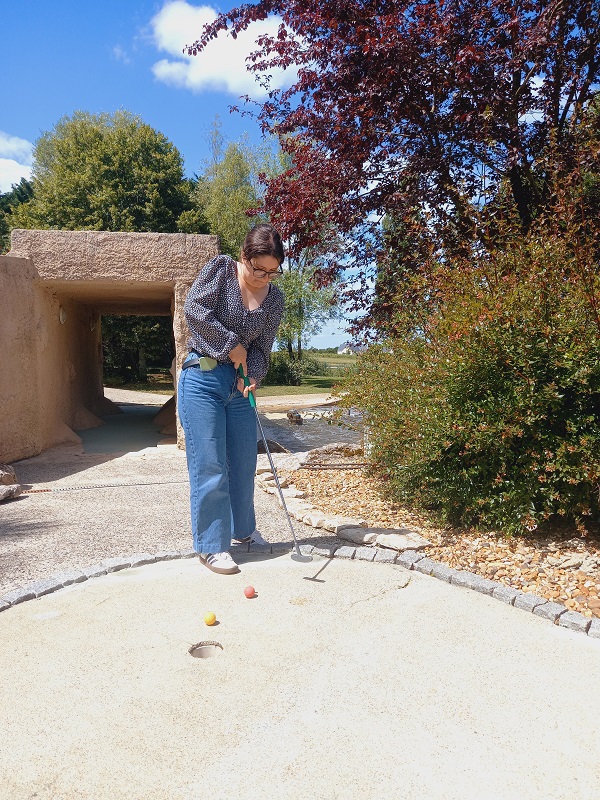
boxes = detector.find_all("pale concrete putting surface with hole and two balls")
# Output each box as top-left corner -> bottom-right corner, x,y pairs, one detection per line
0,553 -> 600,800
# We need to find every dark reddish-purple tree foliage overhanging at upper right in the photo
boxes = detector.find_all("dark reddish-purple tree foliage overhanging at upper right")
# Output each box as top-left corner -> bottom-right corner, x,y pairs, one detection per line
189,0 -> 600,324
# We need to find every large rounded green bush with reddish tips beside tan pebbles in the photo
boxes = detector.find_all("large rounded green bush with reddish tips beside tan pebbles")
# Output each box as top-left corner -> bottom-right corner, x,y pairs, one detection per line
345,236 -> 600,533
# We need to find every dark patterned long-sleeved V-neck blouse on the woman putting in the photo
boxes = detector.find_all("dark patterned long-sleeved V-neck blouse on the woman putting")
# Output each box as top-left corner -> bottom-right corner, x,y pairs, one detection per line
183,255 -> 284,386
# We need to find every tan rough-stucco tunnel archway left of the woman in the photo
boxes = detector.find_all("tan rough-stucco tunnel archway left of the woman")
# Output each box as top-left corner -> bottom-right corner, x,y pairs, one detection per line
0,230 -> 219,462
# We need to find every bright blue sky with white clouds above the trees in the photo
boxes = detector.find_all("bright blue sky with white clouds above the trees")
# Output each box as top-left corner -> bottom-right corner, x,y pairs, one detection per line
0,0 -> 347,347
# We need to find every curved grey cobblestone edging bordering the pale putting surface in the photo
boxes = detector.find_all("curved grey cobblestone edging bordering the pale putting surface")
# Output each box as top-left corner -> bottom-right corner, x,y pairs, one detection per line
0,542 -> 600,639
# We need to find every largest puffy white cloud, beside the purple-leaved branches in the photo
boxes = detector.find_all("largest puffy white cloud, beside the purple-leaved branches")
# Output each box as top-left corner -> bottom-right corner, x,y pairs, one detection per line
150,0 -> 295,98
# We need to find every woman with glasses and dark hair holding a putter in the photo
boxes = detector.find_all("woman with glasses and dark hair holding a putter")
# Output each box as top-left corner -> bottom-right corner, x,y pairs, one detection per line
178,225 -> 285,575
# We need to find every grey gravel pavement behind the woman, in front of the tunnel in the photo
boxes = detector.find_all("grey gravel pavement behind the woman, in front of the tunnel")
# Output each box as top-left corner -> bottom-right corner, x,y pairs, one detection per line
0,445 -> 328,596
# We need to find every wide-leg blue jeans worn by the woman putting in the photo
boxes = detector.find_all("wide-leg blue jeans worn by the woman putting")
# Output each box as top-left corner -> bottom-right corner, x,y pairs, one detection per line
177,364 -> 256,553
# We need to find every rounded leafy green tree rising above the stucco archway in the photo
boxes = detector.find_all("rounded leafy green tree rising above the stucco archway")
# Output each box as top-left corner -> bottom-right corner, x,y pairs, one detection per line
9,111 -> 190,232
